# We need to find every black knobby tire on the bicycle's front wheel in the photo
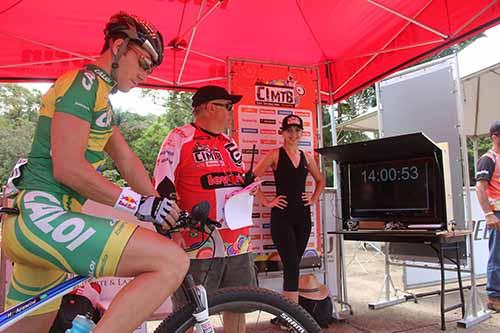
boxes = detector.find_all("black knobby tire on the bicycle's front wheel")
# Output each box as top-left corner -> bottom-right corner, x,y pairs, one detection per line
155,287 -> 321,333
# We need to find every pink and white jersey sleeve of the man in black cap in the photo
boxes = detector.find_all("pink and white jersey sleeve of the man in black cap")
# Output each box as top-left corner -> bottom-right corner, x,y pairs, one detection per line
153,129 -> 183,197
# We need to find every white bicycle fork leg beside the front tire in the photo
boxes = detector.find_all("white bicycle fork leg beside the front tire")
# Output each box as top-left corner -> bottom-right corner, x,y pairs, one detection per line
184,274 -> 215,333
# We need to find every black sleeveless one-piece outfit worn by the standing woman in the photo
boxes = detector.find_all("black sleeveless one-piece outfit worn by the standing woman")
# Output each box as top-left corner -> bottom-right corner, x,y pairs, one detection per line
271,147 -> 311,291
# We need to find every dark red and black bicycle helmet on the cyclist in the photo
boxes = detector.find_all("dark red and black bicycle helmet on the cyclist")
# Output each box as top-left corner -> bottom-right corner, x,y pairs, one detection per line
104,12 -> 163,69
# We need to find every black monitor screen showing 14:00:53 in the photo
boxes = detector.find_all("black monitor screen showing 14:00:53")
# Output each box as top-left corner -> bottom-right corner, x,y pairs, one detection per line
348,158 -> 435,218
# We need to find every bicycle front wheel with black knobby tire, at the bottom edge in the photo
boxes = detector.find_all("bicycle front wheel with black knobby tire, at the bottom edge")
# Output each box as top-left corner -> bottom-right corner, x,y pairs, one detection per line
155,287 -> 321,333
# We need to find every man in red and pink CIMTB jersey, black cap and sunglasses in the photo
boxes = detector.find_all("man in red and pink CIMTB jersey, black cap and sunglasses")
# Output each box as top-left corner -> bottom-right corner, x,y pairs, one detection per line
154,86 -> 256,332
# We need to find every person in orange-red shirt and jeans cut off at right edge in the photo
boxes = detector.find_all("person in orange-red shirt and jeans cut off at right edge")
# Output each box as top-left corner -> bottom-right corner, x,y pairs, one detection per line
476,121 -> 500,312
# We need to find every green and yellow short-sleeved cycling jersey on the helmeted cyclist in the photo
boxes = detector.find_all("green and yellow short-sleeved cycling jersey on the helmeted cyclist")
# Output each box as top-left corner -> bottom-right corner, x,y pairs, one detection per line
17,65 -> 116,204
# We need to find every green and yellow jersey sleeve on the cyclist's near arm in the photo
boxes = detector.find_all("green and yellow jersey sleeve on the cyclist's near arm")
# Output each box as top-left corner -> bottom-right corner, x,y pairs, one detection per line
55,70 -> 98,123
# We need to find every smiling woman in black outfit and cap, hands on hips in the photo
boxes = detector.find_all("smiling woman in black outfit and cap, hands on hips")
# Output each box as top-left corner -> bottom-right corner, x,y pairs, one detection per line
254,115 -> 325,303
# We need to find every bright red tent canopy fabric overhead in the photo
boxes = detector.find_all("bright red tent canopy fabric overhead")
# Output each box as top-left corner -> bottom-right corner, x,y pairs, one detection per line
0,0 -> 500,101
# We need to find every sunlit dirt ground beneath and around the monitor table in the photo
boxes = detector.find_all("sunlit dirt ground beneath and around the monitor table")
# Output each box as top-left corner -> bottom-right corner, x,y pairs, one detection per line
148,242 -> 500,333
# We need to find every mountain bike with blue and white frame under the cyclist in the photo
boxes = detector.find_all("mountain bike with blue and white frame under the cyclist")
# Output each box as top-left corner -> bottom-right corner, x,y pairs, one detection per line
0,202 -> 321,333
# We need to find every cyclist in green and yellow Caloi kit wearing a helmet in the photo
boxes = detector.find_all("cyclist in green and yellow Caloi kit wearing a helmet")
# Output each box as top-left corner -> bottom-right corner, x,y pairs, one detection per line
2,12 -> 189,333
